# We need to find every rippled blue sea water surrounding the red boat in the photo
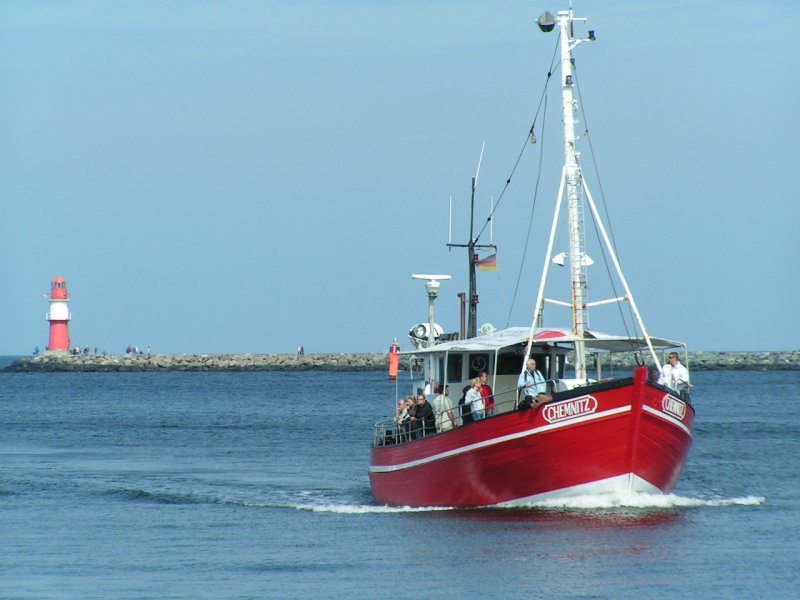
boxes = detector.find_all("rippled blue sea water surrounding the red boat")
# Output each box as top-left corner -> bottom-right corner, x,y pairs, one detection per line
0,358 -> 800,600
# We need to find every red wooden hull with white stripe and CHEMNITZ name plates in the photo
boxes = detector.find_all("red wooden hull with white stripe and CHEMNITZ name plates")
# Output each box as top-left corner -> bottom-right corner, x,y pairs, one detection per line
369,368 -> 694,506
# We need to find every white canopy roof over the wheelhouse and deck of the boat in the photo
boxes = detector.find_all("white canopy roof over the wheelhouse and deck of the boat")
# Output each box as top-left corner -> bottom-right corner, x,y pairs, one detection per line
400,327 -> 683,354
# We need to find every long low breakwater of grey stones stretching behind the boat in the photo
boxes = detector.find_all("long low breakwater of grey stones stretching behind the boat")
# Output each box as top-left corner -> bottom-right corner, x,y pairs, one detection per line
4,351 -> 800,372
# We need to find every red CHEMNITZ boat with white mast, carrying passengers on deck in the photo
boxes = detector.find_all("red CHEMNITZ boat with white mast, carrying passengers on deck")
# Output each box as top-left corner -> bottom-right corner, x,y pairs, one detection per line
369,9 -> 694,507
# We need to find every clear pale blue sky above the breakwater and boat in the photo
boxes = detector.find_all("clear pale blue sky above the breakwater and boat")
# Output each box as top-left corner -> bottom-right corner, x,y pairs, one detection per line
0,0 -> 800,354
